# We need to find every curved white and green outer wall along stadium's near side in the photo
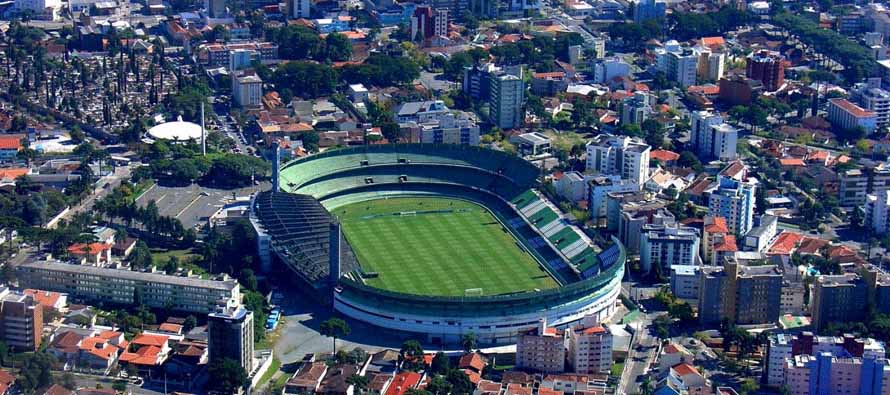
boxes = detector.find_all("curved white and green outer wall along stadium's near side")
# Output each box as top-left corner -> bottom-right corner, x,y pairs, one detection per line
333,254 -> 624,344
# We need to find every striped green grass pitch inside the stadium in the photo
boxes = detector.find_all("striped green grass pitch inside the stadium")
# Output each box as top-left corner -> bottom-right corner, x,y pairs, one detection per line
334,197 -> 557,296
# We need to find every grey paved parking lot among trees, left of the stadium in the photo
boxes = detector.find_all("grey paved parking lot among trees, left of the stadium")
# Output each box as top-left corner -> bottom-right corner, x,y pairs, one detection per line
136,182 -> 270,228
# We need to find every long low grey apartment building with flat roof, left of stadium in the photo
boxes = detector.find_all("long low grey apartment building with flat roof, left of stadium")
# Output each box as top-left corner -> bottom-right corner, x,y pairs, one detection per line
16,261 -> 241,314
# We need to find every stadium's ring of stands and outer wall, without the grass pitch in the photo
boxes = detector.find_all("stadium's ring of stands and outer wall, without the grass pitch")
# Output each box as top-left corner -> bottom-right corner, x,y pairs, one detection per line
251,144 -> 625,344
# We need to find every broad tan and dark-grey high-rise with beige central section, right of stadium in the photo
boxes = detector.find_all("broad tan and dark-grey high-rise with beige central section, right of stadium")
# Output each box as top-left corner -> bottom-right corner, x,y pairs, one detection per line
698,257 -> 782,325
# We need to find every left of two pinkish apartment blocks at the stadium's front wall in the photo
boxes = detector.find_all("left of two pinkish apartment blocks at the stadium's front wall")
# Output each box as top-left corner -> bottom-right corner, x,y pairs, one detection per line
516,320 -> 566,373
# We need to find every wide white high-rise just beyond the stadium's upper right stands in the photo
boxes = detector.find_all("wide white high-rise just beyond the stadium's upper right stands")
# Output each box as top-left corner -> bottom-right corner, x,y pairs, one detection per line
587,134 -> 651,185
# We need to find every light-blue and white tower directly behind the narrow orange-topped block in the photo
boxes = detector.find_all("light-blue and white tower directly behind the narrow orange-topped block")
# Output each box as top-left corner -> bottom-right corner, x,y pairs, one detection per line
708,174 -> 755,237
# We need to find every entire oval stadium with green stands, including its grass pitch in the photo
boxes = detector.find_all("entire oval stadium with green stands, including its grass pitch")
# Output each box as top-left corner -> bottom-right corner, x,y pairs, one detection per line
251,144 -> 625,344
